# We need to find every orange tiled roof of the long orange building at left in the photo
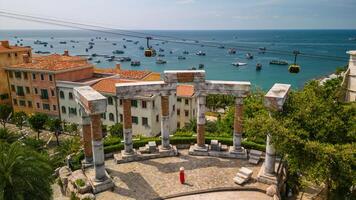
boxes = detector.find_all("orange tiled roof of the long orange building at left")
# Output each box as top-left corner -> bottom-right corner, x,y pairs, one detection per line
8,54 -> 92,71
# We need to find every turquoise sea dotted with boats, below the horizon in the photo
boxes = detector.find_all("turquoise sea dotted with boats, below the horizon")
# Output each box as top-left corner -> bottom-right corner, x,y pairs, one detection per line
0,30 -> 356,89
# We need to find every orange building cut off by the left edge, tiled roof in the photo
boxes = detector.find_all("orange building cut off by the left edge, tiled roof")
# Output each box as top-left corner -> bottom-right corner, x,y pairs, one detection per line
0,41 -> 32,104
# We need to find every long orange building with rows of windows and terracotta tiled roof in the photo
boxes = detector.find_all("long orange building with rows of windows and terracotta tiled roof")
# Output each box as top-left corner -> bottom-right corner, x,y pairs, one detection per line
5,51 -> 94,117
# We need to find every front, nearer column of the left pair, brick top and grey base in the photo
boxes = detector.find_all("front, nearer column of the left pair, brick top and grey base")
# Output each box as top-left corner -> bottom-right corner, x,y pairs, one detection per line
90,114 -> 107,181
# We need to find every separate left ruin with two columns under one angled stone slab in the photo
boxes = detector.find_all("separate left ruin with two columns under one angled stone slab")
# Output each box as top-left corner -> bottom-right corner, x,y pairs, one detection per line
74,86 -> 114,193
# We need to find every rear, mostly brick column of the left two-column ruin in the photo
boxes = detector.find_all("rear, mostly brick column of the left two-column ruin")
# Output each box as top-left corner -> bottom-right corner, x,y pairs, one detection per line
82,113 -> 93,164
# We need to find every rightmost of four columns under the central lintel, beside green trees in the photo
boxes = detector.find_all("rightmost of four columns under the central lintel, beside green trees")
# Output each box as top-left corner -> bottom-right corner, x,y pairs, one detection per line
233,97 -> 243,151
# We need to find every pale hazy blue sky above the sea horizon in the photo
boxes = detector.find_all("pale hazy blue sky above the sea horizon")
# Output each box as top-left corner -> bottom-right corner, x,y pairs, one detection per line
0,0 -> 356,30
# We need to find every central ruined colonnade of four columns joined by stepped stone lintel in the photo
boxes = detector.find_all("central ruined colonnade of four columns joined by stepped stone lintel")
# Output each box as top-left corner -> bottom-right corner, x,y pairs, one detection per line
114,70 -> 251,163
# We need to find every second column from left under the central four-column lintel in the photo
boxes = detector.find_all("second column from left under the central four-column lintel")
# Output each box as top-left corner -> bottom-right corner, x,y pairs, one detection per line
161,95 -> 171,149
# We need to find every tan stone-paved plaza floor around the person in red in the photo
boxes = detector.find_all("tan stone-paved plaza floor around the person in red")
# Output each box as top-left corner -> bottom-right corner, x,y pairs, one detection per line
92,150 -> 268,200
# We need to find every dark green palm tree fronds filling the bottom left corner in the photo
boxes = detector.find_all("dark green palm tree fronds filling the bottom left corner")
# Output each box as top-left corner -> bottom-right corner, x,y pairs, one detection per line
0,142 -> 52,200
